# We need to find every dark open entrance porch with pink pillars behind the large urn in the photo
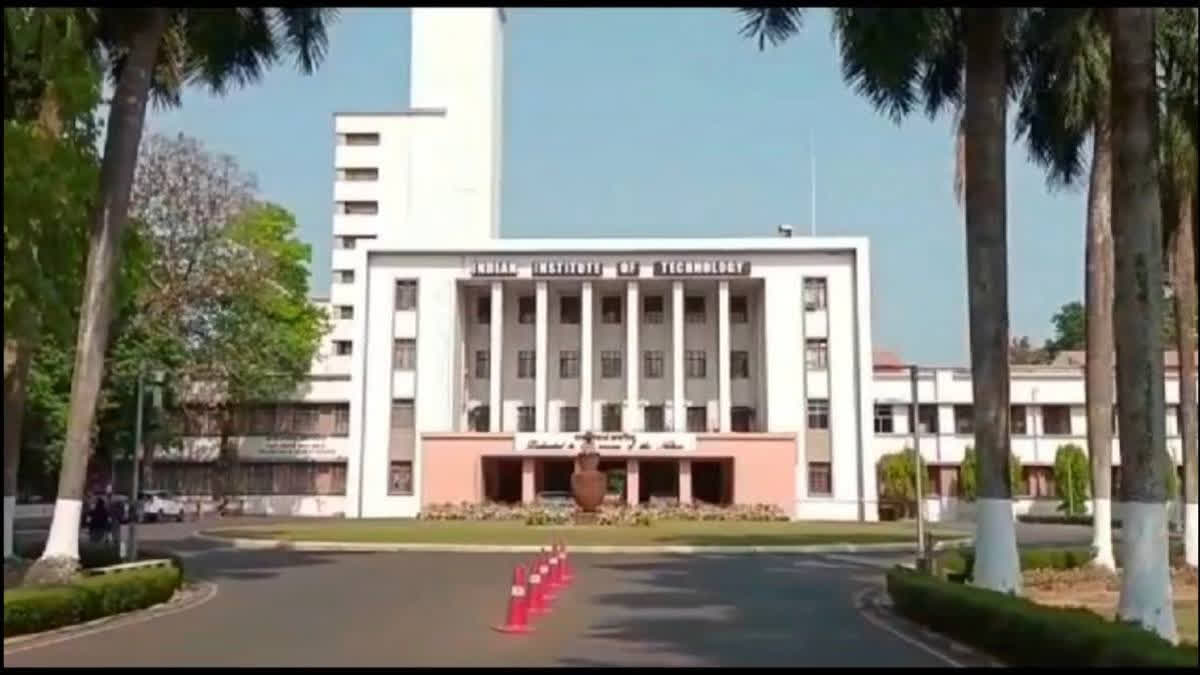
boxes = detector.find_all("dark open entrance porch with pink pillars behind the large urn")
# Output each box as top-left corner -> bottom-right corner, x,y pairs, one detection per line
480,456 -> 734,506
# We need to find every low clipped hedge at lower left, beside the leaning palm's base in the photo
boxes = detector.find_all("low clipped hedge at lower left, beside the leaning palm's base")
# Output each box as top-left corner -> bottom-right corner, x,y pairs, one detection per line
4,565 -> 182,638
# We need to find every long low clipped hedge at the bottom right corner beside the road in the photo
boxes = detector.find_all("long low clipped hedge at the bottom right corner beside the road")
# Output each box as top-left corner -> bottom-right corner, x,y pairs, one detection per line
887,567 -> 1200,668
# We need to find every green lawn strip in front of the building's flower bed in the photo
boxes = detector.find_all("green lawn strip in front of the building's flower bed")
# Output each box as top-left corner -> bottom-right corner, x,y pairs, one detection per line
217,520 -> 964,546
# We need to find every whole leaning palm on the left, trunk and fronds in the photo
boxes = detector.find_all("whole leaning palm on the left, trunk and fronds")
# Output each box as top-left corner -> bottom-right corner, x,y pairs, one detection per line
30,7 -> 336,579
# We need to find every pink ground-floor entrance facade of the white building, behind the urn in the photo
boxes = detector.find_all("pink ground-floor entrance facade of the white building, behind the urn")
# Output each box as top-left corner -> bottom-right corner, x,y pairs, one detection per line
420,432 -> 797,516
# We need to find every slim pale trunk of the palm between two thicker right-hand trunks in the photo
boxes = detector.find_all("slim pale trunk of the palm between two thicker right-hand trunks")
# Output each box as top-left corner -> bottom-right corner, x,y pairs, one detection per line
1084,114 -> 1116,572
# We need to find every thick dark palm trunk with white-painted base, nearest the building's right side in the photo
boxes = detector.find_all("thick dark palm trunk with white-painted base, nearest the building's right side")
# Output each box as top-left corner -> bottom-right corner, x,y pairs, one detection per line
964,8 -> 1021,593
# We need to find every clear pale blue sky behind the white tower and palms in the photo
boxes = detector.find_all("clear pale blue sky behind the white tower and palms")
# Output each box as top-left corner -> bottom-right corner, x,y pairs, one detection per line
149,8 -> 1084,365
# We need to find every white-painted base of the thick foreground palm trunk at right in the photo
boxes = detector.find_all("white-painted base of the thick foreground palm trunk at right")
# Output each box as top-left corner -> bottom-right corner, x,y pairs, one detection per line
1117,502 -> 1178,643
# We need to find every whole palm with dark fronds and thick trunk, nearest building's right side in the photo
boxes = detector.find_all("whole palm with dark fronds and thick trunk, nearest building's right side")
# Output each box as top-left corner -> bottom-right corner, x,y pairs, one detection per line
742,7 -> 1021,592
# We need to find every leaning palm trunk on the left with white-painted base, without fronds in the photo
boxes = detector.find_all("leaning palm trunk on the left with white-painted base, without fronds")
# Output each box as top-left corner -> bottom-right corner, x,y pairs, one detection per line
30,8 -> 168,571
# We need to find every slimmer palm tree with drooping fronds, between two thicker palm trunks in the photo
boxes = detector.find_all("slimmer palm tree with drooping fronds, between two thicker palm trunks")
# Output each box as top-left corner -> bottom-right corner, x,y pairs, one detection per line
1016,8 -> 1116,572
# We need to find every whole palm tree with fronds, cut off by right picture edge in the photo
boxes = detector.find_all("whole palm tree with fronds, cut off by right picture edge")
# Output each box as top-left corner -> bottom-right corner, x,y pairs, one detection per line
1156,7 -> 1198,567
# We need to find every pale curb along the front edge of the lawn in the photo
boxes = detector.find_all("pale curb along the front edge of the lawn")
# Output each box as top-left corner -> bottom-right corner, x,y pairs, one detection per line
192,527 -> 972,555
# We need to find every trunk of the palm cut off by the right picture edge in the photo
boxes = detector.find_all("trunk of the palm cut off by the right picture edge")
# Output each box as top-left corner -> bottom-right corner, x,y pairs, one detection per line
1171,186 -> 1200,567
